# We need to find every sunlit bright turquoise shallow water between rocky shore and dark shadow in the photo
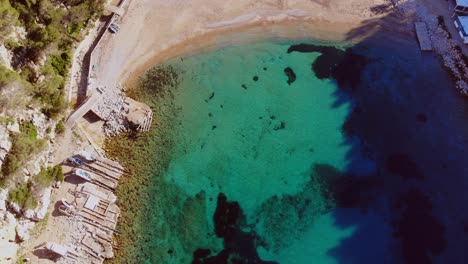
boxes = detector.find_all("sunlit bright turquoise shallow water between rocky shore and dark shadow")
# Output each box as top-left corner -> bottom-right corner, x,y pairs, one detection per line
164,43 -> 372,263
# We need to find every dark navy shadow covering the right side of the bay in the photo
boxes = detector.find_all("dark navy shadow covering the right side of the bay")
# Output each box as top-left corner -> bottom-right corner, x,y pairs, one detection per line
318,1 -> 468,264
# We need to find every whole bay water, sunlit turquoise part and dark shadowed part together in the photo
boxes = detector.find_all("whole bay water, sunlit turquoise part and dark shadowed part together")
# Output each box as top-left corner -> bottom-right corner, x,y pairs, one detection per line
131,36 -> 467,264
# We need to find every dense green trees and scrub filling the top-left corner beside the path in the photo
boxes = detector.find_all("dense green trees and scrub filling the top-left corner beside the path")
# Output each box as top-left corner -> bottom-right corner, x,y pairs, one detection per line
0,0 -> 104,118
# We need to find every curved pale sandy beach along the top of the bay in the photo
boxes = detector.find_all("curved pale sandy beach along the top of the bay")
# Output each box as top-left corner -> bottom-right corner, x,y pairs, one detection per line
97,0 -> 402,92
